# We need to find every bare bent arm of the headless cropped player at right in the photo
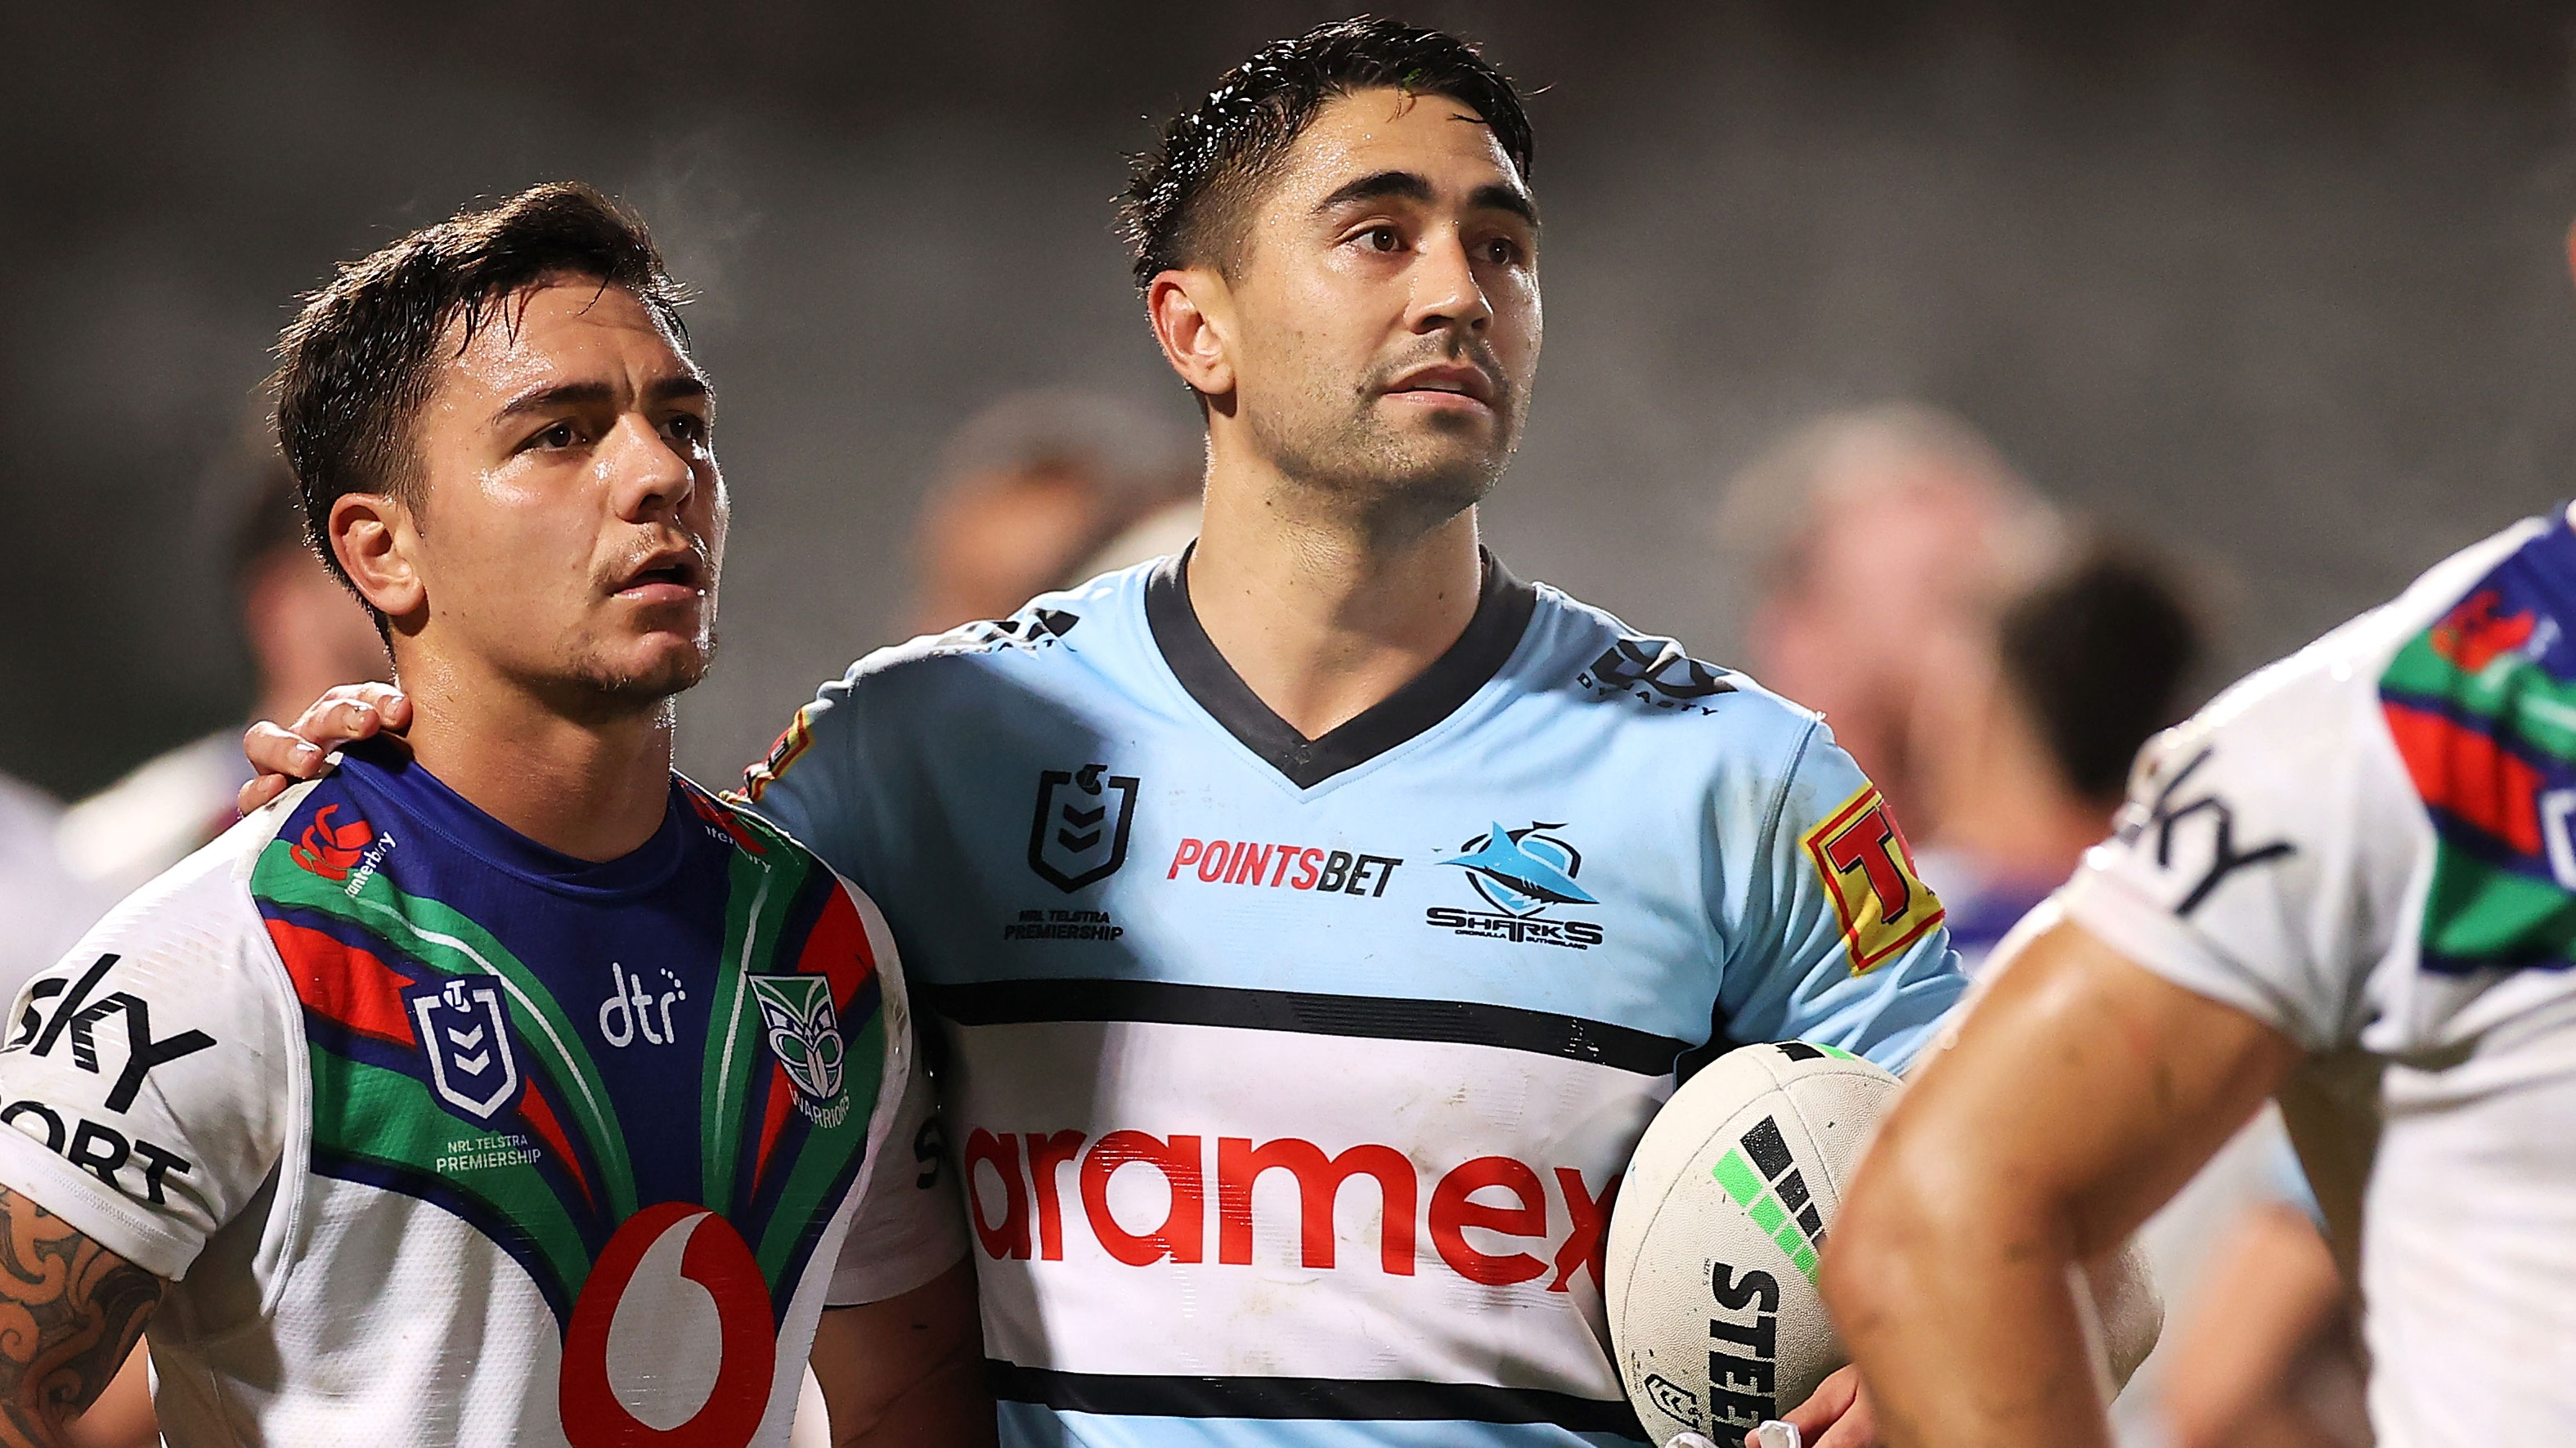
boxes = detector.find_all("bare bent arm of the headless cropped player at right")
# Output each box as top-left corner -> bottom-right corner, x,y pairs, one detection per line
1824,925 -> 2298,1448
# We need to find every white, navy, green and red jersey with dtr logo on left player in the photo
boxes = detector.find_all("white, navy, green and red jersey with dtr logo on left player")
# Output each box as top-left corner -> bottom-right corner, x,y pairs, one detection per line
0,750 -> 963,1448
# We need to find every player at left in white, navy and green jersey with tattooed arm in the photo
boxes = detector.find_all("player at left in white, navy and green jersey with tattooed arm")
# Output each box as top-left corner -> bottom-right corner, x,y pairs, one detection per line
0,186 -> 992,1448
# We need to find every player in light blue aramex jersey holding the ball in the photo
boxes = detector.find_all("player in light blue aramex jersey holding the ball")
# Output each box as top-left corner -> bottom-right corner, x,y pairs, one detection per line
253,20 -> 2153,1448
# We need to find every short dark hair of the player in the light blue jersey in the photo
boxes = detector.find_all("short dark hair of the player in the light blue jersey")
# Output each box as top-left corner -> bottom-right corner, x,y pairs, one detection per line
1118,16 -> 1530,289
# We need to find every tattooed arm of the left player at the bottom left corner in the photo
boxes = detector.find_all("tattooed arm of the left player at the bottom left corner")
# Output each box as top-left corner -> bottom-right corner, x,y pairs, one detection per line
0,1188 -> 162,1448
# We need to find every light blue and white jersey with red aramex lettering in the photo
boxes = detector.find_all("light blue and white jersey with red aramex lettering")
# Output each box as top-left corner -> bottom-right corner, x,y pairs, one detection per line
750,546 -> 1960,1446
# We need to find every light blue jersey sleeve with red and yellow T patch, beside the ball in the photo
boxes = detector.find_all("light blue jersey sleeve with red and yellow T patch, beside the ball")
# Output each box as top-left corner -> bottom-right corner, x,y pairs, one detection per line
1713,721 -> 1968,1072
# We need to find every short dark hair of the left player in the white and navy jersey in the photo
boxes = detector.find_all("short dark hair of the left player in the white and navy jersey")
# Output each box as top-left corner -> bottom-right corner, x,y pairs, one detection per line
276,181 -> 688,600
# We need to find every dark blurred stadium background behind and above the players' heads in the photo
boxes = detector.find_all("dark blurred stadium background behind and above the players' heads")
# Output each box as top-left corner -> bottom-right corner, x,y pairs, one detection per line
15,2 -> 2576,796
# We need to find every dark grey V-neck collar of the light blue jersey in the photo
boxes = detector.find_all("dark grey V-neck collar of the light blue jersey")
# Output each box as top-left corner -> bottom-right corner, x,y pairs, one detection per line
1144,544 -> 1538,788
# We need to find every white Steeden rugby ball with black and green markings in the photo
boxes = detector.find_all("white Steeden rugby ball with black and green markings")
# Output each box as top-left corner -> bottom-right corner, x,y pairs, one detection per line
1602,1041 -> 1899,1446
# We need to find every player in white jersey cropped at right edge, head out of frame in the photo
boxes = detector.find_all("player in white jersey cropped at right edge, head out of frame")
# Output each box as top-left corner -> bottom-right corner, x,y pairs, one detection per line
1824,508 -> 2576,1448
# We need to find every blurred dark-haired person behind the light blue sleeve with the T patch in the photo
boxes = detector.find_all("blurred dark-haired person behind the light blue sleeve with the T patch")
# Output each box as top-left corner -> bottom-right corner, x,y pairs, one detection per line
1917,546 -> 2208,971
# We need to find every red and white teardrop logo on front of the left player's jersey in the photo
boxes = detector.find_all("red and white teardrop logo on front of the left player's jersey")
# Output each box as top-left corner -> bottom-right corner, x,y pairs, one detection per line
556,1200 -> 778,1448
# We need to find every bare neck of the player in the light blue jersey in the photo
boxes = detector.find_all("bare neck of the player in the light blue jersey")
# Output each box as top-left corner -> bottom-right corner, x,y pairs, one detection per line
1190,468 -> 1483,739
